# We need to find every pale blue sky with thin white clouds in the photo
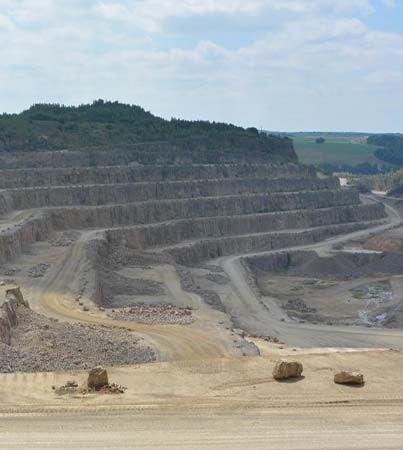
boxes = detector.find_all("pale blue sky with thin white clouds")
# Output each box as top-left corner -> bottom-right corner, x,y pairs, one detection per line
0,0 -> 403,132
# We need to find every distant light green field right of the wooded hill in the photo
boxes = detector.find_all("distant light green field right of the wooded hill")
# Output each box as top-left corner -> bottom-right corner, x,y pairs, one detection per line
290,134 -> 380,166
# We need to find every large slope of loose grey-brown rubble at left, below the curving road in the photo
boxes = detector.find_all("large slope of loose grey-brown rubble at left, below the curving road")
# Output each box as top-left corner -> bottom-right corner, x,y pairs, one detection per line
0,307 -> 155,373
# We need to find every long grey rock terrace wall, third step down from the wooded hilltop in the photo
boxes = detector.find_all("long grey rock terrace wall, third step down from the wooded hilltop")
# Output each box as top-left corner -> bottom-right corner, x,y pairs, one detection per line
6,178 -> 338,213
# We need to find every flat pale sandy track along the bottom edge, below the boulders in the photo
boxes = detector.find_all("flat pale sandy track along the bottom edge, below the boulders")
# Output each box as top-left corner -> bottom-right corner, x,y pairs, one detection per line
0,406 -> 403,450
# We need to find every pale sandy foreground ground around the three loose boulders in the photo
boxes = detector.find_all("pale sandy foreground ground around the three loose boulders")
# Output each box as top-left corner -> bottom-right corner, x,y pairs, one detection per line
0,350 -> 403,450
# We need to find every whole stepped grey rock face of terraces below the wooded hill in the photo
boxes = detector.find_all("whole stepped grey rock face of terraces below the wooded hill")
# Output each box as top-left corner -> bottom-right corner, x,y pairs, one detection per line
0,153 -> 385,274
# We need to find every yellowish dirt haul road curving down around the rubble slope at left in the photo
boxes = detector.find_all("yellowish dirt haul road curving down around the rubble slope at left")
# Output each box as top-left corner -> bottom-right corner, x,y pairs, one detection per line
22,231 -> 231,361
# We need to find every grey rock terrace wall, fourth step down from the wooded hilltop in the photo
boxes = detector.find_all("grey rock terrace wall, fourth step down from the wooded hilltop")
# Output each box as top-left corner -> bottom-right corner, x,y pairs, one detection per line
49,190 -> 359,229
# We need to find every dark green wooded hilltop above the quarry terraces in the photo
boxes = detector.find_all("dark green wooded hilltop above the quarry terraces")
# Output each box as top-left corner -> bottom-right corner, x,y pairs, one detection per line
0,100 -> 297,161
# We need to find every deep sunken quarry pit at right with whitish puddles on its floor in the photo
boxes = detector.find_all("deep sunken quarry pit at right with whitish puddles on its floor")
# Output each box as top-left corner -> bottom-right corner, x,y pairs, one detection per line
246,251 -> 403,328
